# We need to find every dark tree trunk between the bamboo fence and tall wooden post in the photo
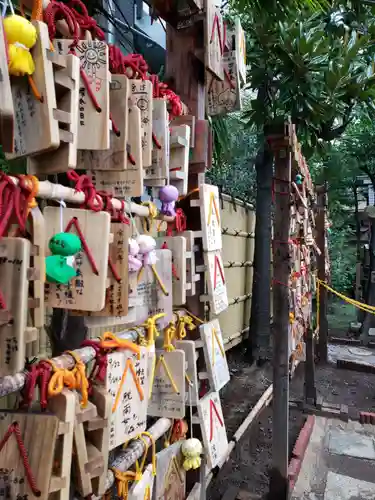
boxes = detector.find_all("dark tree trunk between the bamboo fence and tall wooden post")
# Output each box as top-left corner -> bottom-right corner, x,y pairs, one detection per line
247,140 -> 273,364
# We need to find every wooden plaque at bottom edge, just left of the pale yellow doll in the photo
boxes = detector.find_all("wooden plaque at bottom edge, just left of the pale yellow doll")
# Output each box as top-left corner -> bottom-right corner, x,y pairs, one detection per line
155,441 -> 186,500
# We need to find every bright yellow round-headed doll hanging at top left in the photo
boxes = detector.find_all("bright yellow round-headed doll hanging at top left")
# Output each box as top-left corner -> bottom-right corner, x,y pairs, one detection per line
3,15 -> 37,76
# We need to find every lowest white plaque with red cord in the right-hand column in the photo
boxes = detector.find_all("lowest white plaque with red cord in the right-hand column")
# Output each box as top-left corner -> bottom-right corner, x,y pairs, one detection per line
198,392 -> 228,470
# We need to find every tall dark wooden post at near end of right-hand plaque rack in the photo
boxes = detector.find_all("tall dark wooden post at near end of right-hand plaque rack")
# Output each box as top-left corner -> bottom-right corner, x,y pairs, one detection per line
269,125 -> 291,500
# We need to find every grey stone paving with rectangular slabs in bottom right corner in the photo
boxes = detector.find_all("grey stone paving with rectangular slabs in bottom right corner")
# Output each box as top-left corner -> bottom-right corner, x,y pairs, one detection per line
292,417 -> 375,500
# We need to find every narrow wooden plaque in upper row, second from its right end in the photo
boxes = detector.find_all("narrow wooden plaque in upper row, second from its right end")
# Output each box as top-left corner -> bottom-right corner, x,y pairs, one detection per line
145,99 -> 170,186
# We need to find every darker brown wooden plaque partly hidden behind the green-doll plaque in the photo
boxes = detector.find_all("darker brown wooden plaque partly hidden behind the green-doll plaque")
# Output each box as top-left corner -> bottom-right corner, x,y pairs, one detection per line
85,222 -> 130,317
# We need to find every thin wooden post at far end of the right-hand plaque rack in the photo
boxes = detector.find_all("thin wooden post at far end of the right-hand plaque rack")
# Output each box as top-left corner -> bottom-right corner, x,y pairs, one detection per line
316,186 -> 328,363
